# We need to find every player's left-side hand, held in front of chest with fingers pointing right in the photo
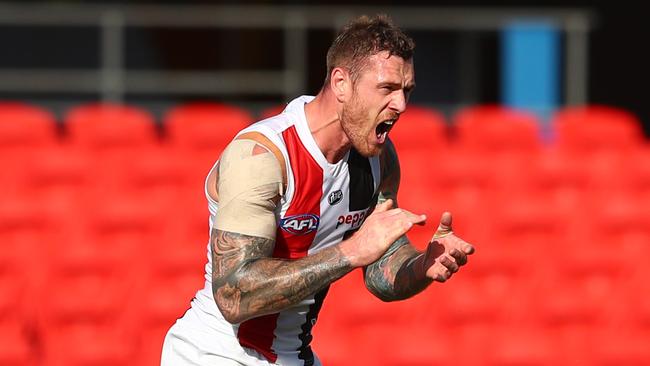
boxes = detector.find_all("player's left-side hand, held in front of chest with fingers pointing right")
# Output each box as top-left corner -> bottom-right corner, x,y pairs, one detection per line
340,199 -> 427,267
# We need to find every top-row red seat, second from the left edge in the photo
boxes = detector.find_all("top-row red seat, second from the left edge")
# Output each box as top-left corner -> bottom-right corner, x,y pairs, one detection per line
64,103 -> 157,154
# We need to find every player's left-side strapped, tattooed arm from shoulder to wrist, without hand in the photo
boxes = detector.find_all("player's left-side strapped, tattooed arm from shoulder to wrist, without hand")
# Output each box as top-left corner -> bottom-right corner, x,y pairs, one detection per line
210,139 -> 352,323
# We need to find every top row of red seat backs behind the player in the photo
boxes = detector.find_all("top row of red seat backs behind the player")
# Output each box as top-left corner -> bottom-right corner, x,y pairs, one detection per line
0,102 -> 644,153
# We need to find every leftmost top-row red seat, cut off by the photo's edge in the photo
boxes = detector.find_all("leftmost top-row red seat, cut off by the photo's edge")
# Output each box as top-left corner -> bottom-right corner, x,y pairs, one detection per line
0,102 -> 56,149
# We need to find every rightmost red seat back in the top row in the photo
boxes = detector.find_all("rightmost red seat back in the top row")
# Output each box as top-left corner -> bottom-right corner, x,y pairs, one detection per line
552,105 -> 643,153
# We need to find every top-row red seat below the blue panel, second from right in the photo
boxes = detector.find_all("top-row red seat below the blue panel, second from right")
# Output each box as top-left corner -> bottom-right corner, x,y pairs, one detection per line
454,105 -> 541,154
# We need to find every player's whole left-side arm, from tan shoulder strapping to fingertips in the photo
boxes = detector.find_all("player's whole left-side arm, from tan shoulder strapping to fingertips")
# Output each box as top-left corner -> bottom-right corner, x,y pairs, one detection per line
210,137 -> 424,324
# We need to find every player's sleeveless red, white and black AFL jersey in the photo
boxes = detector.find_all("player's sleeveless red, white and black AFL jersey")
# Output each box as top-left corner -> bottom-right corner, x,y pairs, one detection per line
179,96 -> 380,366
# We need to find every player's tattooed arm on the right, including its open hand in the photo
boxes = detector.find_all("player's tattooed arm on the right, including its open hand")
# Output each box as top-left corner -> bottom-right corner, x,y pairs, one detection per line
364,140 -> 474,301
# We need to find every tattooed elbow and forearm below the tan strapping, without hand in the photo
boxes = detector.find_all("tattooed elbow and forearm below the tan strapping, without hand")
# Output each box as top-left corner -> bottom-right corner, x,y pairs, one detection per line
210,229 -> 352,323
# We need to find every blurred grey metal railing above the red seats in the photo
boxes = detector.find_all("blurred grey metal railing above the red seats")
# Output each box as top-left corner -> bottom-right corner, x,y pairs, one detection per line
0,3 -> 594,104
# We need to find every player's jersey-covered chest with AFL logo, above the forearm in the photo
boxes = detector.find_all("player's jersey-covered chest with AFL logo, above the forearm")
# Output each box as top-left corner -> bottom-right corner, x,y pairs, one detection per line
274,151 -> 379,259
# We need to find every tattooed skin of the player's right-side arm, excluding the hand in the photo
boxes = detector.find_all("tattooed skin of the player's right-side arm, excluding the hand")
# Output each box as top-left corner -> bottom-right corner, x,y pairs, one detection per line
364,145 -> 432,301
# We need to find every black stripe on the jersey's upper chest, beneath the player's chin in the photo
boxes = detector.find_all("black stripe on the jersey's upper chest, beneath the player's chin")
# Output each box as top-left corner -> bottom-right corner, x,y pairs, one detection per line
348,149 -> 375,211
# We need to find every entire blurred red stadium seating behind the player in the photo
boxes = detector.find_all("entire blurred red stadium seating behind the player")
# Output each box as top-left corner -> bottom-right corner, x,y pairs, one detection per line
0,103 -> 650,366
